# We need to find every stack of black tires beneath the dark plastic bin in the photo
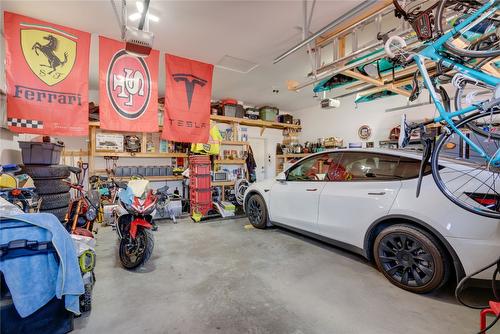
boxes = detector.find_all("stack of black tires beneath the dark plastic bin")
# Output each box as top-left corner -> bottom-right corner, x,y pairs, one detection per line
24,165 -> 71,222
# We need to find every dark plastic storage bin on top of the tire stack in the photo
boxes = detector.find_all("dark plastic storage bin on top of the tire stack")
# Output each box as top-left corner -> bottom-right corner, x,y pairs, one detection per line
19,141 -> 64,165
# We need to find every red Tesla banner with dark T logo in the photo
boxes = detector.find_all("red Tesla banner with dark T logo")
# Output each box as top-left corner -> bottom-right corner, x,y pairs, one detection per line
162,54 -> 214,143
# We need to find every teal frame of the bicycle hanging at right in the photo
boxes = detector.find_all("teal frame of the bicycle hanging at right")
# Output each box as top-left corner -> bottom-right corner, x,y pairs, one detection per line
413,0 -> 500,166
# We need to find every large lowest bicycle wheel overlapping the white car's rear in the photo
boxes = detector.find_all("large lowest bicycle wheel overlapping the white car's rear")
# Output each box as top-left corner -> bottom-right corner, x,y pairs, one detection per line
431,111 -> 500,219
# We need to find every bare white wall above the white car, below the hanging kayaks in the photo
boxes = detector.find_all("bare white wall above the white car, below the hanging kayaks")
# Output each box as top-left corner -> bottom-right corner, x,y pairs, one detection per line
293,92 -> 437,147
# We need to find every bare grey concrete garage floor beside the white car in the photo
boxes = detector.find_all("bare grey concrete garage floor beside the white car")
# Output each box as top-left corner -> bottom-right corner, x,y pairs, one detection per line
75,219 -> 492,334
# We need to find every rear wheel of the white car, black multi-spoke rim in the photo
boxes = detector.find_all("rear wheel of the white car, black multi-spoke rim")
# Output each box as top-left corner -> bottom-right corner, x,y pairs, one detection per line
373,224 -> 449,293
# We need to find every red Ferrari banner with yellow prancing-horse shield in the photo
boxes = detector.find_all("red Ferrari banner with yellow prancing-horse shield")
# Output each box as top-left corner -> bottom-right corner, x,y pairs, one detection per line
4,12 -> 90,136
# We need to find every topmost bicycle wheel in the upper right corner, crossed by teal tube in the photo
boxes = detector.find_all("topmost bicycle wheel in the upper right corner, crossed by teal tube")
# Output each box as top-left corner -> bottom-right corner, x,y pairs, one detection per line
436,0 -> 500,58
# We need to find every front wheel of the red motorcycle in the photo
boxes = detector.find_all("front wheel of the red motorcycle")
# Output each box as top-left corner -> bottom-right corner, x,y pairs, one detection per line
119,228 -> 155,270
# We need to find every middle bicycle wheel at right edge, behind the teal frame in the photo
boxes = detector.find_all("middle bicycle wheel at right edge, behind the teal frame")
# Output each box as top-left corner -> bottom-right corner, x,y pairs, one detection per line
455,79 -> 500,140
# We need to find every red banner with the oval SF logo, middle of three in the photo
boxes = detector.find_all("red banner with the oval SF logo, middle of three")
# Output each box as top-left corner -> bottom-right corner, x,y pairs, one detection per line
99,36 -> 160,132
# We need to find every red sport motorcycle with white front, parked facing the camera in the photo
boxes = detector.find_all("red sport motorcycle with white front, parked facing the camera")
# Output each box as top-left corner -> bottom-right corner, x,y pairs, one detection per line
115,179 -> 158,269
